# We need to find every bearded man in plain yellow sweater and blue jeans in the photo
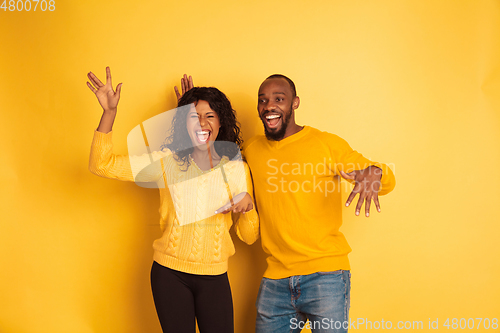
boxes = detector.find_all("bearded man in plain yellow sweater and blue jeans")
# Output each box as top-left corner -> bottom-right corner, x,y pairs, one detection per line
176,74 -> 395,333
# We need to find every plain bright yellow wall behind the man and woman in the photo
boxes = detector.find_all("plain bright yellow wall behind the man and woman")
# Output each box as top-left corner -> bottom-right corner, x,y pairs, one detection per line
0,0 -> 500,333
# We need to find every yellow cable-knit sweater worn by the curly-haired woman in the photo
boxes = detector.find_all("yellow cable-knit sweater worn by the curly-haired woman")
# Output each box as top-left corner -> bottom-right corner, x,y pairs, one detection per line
89,131 -> 259,275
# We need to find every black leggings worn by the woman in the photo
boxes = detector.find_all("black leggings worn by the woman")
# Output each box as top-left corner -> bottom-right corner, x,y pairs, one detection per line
151,262 -> 234,333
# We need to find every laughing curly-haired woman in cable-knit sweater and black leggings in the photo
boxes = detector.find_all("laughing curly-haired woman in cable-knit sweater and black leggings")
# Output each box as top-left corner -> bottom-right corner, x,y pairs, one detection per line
87,67 -> 259,333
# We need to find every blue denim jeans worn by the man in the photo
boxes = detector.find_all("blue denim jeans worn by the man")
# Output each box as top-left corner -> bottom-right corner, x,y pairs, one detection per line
255,270 -> 351,333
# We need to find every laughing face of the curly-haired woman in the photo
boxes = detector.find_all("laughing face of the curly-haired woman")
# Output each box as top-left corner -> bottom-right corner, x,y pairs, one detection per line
186,100 -> 220,150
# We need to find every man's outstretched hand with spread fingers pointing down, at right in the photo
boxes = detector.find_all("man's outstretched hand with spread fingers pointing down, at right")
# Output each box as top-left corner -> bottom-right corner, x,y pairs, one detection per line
340,166 -> 382,217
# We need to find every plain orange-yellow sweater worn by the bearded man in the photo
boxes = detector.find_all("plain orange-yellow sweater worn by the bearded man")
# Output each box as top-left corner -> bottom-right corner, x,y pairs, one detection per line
243,126 -> 395,279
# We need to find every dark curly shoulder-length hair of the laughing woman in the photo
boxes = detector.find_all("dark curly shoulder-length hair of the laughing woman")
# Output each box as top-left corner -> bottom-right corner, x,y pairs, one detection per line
161,87 -> 243,171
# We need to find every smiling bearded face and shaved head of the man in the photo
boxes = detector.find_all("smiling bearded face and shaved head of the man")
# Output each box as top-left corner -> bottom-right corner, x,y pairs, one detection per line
257,78 -> 294,141
